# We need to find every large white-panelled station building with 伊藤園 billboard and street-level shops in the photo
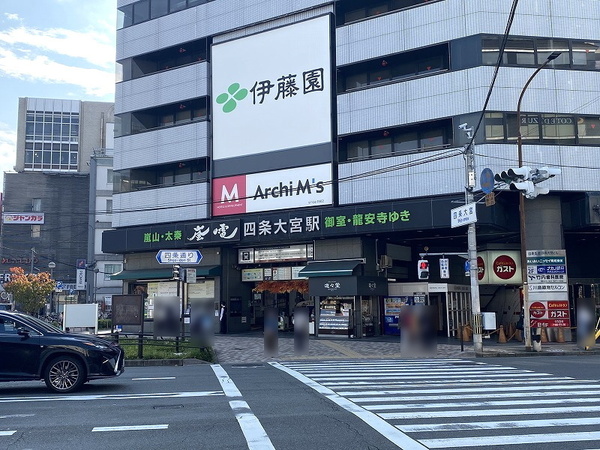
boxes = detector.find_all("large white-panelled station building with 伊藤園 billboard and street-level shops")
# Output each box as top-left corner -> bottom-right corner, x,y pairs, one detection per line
108,0 -> 600,336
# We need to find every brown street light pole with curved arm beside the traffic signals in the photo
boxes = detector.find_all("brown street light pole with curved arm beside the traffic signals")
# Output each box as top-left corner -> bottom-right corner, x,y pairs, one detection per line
517,52 -> 561,350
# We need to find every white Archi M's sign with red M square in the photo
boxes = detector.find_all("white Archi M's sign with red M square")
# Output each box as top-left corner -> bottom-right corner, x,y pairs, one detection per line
212,164 -> 333,216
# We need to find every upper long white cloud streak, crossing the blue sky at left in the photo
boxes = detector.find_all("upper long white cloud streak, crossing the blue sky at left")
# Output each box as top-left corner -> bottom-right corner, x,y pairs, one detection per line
0,27 -> 115,68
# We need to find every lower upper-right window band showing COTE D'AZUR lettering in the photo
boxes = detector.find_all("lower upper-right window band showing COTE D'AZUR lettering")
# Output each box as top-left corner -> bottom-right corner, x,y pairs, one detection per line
485,112 -> 600,146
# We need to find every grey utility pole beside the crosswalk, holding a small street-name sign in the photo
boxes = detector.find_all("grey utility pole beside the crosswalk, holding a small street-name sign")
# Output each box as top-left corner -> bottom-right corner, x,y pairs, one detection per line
459,123 -> 483,353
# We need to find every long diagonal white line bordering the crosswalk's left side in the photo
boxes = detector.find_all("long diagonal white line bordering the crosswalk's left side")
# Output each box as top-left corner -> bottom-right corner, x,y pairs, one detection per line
269,362 -> 427,450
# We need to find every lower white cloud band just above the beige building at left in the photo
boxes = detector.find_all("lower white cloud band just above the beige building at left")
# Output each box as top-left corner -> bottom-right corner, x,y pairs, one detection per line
0,48 -> 115,97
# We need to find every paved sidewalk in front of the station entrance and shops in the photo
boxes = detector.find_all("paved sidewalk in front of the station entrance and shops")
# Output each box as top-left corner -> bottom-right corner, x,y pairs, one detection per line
214,332 -> 600,364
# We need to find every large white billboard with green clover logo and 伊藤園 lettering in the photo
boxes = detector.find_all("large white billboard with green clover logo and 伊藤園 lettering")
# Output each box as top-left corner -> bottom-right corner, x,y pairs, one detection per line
211,16 -> 332,160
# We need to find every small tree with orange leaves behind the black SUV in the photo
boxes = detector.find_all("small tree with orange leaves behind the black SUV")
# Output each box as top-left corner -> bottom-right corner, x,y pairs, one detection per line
4,267 -> 56,314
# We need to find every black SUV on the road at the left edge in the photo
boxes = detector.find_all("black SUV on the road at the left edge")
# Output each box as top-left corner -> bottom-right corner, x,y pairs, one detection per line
0,311 -> 124,393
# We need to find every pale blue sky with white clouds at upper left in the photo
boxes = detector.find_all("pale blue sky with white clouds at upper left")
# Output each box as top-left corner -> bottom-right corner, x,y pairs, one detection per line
0,0 -> 117,191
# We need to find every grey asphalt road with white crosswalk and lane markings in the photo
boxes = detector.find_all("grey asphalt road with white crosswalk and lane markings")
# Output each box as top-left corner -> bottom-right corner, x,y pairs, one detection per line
0,356 -> 600,450
